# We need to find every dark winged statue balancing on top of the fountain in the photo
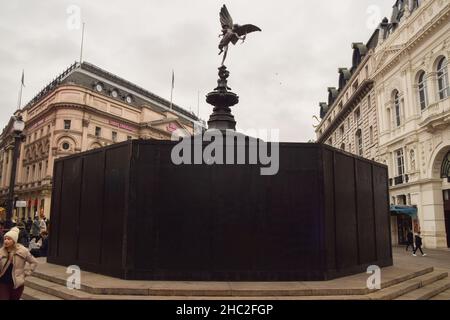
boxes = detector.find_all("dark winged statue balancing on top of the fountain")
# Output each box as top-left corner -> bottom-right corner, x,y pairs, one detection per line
219,5 -> 261,65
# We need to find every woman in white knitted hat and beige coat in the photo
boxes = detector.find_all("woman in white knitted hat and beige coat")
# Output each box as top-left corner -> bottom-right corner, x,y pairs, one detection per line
0,227 -> 38,300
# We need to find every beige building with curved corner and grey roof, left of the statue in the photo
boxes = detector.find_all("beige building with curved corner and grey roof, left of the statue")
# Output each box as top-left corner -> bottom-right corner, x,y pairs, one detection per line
0,62 -> 204,218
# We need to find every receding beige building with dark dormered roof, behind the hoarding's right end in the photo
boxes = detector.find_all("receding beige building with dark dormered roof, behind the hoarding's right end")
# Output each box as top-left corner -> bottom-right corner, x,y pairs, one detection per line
316,30 -> 379,161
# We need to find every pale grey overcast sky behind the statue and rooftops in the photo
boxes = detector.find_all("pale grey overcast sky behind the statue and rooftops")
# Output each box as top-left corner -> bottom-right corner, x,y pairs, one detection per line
0,0 -> 395,142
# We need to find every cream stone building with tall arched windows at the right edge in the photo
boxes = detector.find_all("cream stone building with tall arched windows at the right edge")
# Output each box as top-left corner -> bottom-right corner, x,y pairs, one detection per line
371,0 -> 450,248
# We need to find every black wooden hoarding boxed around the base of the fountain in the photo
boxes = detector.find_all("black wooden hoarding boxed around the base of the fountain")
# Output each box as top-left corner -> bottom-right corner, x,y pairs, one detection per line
48,140 -> 392,281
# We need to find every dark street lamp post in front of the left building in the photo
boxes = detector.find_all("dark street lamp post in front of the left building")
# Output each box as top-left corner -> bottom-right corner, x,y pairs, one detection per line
5,116 -> 25,229
